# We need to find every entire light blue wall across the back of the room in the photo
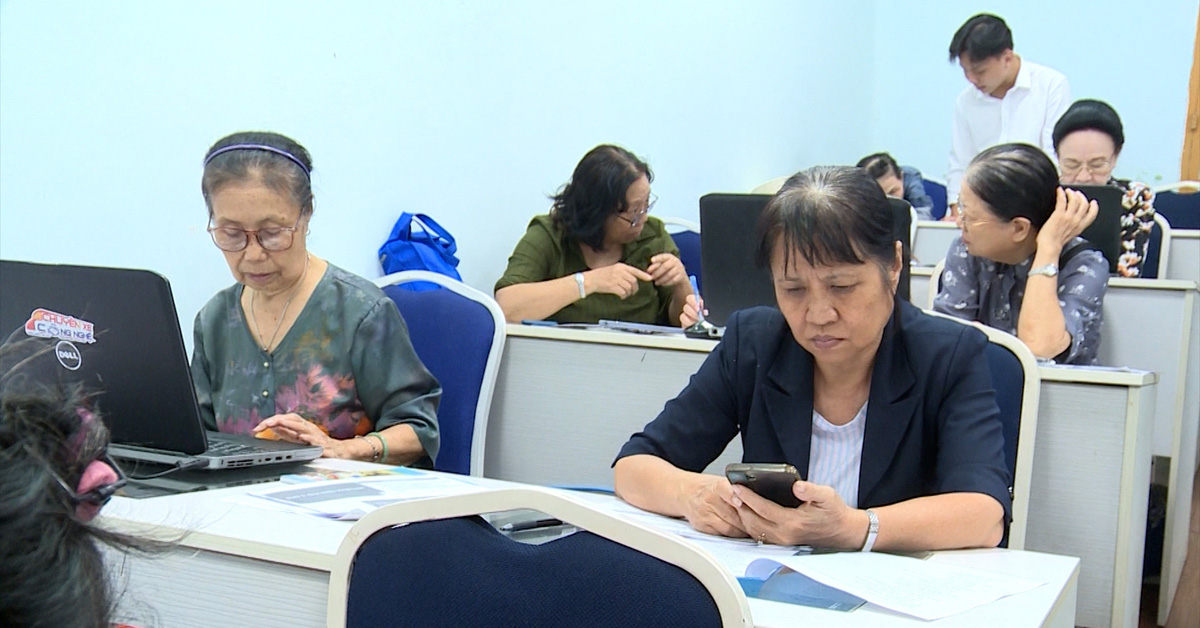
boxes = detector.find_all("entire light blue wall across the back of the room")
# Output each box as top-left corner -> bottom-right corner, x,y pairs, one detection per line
0,0 -> 1196,348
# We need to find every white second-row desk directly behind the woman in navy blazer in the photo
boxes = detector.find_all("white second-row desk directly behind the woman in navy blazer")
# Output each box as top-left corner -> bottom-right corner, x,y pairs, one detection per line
485,325 -> 1156,626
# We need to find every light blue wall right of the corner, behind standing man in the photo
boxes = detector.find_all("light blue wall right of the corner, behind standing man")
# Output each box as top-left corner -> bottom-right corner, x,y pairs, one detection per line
864,0 -> 1200,185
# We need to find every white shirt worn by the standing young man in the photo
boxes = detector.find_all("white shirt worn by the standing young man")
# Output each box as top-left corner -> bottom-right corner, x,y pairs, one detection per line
946,59 -> 1070,203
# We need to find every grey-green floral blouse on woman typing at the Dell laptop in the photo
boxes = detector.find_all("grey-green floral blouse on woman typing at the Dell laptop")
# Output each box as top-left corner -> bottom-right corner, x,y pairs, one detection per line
192,264 -> 442,463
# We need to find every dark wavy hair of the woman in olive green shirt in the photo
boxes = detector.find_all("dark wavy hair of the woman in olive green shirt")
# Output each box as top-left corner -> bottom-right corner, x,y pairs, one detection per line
550,144 -> 654,250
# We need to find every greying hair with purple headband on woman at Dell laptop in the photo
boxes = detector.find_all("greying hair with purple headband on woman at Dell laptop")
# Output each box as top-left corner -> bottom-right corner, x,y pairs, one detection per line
200,131 -> 312,219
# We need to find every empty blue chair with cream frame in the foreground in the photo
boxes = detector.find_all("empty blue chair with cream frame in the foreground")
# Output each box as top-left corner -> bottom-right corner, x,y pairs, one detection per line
326,486 -> 752,628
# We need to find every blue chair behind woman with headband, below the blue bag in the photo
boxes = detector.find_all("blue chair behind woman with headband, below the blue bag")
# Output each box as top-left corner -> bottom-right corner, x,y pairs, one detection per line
376,270 -> 506,476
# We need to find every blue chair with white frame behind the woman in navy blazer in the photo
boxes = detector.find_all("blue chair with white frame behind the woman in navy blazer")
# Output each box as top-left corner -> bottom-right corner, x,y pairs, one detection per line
930,312 -> 1042,550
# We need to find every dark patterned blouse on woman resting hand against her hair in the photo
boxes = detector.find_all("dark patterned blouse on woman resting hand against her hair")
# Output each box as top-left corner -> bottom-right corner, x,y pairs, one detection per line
934,238 -> 1109,364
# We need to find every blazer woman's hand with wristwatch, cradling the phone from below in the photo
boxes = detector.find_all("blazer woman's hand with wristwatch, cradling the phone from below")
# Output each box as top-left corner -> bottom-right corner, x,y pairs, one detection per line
732,480 -> 868,549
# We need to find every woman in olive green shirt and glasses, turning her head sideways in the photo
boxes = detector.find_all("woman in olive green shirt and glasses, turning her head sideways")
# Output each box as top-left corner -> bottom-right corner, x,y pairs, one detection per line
496,144 -> 691,325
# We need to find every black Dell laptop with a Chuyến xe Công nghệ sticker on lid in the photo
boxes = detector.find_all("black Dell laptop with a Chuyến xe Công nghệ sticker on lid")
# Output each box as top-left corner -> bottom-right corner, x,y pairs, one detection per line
0,259 -> 322,469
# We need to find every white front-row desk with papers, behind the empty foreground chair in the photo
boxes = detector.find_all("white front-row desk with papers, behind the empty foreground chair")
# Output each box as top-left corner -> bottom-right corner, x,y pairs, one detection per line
101,463 -> 1079,628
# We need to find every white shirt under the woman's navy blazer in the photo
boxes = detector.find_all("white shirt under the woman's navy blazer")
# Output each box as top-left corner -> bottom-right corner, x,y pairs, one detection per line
809,403 -> 866,508
